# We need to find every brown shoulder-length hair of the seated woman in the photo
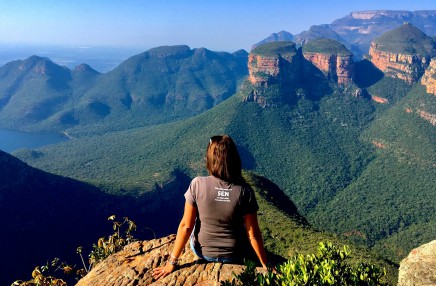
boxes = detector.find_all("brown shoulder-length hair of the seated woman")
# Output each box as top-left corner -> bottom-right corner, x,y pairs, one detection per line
206,135 -> 242,183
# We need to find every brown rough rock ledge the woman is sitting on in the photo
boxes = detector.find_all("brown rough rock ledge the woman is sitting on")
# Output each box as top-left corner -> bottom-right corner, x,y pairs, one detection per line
77,235 -> 261,286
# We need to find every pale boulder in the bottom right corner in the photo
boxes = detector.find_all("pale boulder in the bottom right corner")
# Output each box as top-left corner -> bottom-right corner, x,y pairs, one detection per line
398,240 -> 436,286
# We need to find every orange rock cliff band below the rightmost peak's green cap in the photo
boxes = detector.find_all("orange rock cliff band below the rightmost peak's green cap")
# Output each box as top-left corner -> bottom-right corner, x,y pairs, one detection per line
369,42 -> 430,84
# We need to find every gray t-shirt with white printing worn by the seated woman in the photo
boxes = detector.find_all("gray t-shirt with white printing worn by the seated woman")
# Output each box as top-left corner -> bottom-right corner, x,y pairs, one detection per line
185,176 -> 259,258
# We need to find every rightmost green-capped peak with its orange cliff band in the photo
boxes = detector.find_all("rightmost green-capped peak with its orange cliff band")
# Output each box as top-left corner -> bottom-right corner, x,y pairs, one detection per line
369,23 -> 436,84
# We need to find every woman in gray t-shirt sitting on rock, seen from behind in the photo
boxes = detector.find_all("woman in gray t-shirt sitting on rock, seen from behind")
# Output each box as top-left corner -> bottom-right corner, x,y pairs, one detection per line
153,135 -> 267,279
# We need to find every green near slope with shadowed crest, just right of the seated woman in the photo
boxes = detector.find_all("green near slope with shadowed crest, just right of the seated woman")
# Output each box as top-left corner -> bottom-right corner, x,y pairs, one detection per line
244,172 -> 398,285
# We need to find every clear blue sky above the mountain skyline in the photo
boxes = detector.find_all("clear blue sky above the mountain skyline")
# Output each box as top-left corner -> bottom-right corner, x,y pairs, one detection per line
0,0 -> 436,52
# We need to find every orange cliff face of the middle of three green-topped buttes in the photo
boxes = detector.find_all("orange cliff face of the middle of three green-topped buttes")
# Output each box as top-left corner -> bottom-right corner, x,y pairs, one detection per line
303,52 -> 354,85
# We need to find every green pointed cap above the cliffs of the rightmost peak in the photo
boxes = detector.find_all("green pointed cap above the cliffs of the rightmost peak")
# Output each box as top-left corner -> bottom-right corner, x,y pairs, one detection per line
374,23 -> 436,57
